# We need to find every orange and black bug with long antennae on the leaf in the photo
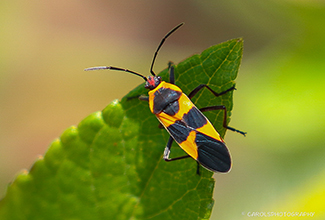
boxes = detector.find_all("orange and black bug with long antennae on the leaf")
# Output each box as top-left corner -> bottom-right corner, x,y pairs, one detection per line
85,23 -> 246,174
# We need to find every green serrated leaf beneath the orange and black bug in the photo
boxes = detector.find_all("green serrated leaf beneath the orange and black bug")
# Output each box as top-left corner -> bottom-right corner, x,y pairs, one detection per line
0,39 -> 243,220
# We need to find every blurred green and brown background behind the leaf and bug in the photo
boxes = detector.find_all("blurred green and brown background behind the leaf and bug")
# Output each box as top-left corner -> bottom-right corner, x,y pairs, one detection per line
0,0 -> 325,220
